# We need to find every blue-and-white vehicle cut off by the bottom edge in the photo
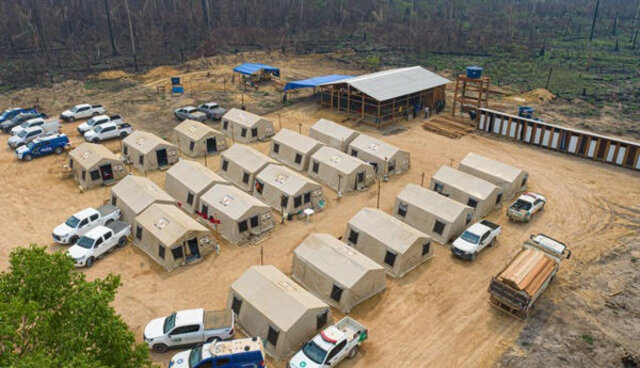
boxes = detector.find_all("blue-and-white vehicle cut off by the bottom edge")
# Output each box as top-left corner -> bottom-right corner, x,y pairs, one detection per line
169,337 -> 267,368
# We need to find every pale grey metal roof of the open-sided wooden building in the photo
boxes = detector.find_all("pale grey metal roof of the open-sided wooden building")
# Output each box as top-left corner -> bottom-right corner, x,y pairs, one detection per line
323,66 -> 451,101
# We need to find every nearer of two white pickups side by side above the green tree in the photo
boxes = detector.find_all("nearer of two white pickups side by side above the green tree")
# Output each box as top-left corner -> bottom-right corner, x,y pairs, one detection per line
67,221 -> 131,267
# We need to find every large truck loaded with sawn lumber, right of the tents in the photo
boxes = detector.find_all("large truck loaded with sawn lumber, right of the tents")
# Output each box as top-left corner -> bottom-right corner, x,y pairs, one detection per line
489,234 -> 571,319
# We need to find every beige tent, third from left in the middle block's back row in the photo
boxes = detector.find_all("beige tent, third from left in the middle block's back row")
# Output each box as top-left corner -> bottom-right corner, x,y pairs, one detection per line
218,144 -> 278,193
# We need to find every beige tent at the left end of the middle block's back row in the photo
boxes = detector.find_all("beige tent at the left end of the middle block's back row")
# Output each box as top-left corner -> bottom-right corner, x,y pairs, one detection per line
111,175 -> 175,226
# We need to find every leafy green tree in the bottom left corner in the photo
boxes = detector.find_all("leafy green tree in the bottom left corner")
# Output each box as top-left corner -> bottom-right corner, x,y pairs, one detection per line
0,245 -> 152,368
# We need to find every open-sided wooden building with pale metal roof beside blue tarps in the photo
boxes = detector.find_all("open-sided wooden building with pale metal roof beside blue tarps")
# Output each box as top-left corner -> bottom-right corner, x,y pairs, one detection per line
320,66 -> 450,128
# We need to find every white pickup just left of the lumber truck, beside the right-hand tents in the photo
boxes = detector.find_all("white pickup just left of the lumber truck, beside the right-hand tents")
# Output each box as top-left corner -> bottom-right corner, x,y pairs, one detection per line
451,220 -> 502,261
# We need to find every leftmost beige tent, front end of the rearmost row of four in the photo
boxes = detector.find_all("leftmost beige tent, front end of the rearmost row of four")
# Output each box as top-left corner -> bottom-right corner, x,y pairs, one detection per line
69,143 -> 127,189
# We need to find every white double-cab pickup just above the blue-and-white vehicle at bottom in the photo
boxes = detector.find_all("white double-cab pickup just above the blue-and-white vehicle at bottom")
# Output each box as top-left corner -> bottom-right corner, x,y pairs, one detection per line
143,308 -> 235,353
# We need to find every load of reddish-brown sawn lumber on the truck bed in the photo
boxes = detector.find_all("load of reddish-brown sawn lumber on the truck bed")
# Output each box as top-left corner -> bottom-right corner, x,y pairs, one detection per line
498,249 -> 556,297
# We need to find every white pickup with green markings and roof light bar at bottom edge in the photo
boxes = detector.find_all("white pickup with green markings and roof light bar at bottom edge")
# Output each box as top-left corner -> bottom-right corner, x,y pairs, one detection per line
288,317 -> 368,368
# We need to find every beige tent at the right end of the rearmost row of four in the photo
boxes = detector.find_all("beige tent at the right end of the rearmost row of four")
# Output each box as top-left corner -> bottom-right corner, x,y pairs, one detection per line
222,109 -> 274,143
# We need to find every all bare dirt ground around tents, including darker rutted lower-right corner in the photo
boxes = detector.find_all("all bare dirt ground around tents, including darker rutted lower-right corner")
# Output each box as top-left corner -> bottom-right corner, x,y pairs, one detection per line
0,52 -> 640,368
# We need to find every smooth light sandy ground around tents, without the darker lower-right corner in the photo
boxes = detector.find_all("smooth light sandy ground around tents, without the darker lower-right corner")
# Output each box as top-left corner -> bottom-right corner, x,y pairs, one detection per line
0,99 -> 640,367
